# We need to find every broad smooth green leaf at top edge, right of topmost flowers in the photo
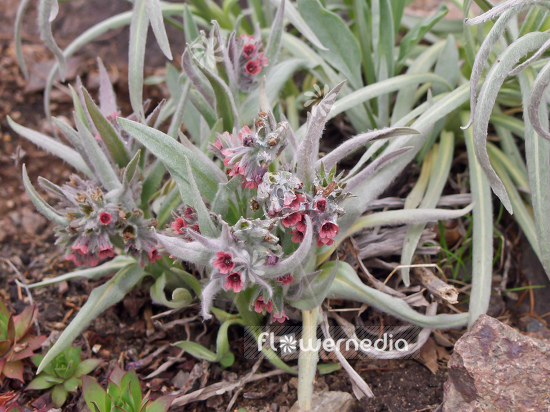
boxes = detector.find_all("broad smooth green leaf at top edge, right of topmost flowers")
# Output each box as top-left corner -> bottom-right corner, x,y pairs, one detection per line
298,0 -> 363,88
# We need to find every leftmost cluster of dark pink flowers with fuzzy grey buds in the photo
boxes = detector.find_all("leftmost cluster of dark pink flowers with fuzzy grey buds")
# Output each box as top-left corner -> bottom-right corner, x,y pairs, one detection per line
44,175 -> 160,266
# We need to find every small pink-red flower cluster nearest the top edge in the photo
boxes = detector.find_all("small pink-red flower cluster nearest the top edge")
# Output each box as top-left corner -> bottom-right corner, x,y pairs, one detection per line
237,34 -> 268,91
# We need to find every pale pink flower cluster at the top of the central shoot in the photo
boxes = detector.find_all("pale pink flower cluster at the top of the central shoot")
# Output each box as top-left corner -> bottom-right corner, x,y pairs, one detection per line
211,112 -> 289,189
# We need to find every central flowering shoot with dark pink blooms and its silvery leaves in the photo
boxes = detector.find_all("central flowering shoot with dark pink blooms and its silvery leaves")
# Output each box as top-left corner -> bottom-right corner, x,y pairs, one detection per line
118,84 -> 470,407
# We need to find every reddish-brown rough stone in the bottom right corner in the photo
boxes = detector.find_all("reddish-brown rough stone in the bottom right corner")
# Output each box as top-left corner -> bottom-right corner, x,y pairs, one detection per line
438,315 -> 550,412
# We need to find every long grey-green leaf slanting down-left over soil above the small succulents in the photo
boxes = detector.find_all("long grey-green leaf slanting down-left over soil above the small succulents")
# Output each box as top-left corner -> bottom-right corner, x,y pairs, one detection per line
37,263 -> 144,373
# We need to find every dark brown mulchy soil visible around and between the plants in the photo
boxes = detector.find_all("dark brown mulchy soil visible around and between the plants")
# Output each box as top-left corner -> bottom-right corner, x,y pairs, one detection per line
0,0 -> 550,412
